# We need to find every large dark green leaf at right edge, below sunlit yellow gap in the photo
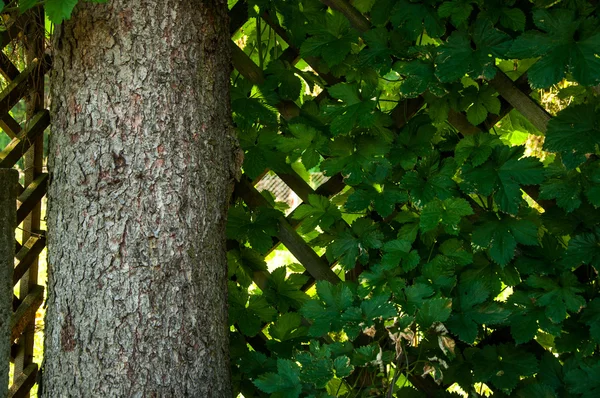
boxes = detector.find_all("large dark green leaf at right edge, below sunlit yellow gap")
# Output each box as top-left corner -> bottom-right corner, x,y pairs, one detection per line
544,104 -> 600,169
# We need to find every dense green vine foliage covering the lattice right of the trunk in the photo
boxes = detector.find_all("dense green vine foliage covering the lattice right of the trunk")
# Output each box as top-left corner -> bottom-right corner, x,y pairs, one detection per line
228,0 -> 600,397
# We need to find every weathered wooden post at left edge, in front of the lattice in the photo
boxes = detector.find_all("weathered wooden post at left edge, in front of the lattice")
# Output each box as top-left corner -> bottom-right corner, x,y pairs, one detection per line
0,169 -> 19,397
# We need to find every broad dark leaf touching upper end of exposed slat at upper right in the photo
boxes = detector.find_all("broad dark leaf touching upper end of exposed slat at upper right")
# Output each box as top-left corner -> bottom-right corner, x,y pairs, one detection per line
435,19 -> 512,83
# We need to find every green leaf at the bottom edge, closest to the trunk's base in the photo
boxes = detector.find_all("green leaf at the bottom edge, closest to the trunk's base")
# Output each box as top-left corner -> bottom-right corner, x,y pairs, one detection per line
253,358 -> 302,398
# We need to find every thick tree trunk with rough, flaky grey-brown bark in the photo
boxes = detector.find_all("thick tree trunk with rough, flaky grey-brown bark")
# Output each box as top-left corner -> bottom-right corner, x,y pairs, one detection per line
43,0 -> 234,398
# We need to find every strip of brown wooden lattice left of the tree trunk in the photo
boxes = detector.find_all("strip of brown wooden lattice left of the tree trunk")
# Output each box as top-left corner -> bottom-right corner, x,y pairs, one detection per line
0,7 -> 50,397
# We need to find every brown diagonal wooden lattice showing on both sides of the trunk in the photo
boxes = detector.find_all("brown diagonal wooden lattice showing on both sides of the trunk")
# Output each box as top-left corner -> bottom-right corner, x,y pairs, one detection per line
0,0 -> 554,397
